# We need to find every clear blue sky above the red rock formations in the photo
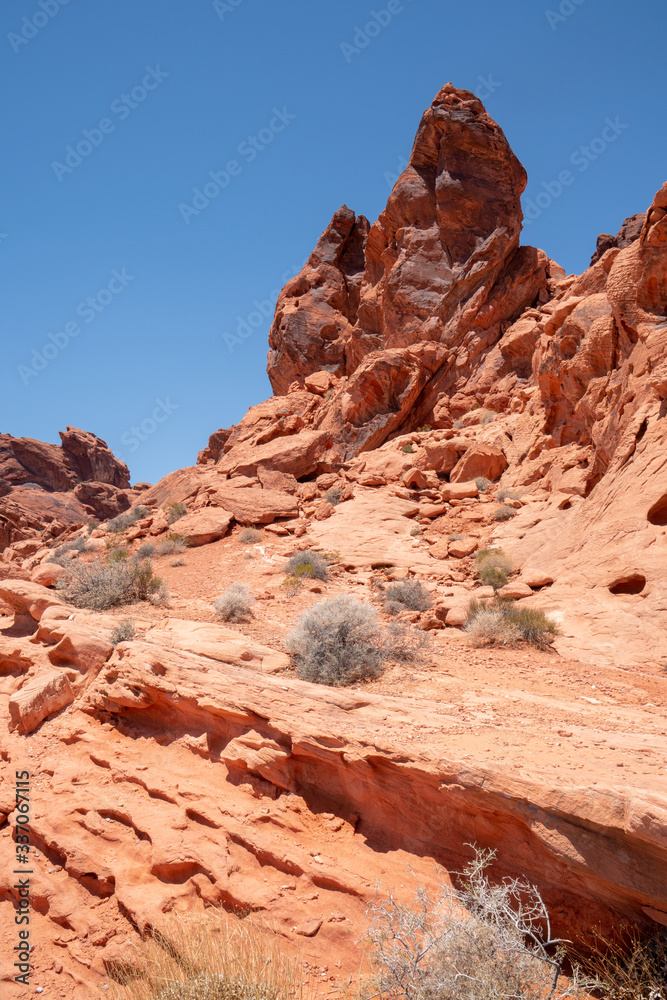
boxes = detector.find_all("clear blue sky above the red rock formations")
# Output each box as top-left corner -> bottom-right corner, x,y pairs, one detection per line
0,0 -> 667,482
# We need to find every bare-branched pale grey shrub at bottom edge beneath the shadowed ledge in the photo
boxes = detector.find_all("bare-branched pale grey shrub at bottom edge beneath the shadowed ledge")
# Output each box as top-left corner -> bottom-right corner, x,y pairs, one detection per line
369,850 -> 580,1000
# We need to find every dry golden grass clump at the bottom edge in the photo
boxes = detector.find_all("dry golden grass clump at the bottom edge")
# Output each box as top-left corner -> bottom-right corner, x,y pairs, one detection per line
109,910 -> 303,1000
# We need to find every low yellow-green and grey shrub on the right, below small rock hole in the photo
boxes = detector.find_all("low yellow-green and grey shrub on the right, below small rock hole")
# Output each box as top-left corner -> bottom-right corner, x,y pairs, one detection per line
463,598 -> 561,649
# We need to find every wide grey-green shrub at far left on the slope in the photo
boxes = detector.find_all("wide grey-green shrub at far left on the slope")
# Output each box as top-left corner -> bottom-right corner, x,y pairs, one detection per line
63,559 -> 166,611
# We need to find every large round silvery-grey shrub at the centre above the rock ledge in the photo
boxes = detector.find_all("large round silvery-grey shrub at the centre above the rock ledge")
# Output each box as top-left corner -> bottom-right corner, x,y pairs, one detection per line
285,594 -> 385,686
